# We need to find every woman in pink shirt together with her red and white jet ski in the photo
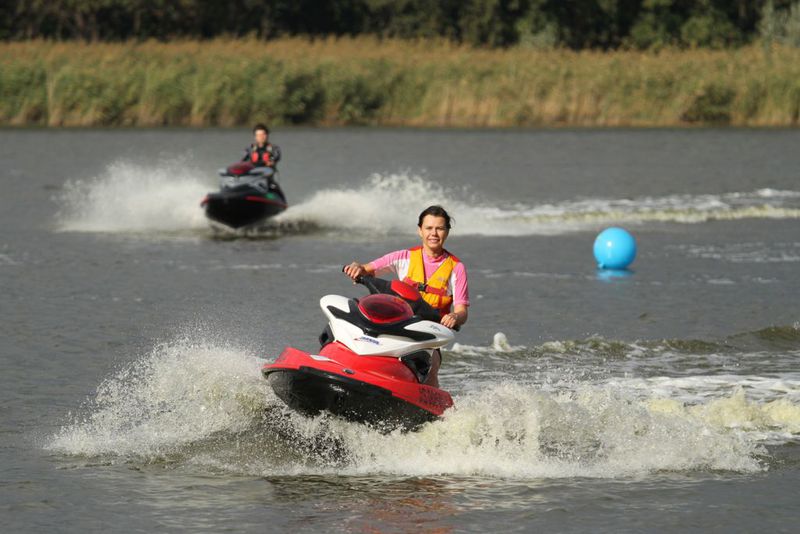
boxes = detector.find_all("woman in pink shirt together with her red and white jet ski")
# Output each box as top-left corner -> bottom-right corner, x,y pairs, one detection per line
263,206 -> 469,430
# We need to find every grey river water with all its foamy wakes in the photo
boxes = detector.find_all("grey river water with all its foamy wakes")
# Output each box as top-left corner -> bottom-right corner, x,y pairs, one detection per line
0,129 -> 800,532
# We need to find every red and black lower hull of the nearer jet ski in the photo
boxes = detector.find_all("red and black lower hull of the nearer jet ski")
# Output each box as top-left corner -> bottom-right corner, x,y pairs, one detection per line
262,342 -> 453,431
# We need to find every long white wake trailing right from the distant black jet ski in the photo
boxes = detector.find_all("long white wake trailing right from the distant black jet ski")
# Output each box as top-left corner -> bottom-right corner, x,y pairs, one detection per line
277,173 -> 800,236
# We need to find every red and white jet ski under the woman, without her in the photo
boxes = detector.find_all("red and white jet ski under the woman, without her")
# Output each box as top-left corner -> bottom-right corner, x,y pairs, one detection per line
262,277 -> 454,431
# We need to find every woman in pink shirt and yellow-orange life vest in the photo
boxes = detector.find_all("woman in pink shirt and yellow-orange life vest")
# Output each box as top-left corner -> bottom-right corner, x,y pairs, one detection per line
344,206 -> 469,387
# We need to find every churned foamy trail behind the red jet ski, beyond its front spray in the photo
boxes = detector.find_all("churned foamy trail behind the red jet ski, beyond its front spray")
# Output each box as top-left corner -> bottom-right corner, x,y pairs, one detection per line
448,333 -> 800,443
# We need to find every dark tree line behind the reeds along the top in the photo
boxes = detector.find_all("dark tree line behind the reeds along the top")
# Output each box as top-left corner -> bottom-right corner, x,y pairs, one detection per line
0,0 -> 800,50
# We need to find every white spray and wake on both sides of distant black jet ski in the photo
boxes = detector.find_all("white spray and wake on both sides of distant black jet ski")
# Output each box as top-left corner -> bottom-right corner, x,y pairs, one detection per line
56,161 -> 800,238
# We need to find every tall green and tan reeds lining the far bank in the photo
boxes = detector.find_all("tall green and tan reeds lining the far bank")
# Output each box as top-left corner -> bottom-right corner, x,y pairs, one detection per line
0,37 -> 800,127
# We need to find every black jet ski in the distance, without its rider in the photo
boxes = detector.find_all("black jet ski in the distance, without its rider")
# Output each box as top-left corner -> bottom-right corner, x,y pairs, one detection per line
200,161 -> 287,228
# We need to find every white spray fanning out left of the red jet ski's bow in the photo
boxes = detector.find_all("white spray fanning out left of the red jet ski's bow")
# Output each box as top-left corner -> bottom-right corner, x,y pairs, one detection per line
47,339 -> 266,458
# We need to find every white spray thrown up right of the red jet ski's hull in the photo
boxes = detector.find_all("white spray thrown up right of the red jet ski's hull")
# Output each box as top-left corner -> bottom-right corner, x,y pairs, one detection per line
336,383 -> 762,479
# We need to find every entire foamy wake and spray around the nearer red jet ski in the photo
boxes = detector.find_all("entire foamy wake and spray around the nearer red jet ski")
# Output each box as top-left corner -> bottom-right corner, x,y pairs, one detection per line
46,328 -> 800,479
